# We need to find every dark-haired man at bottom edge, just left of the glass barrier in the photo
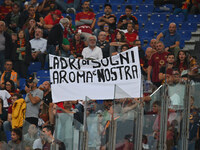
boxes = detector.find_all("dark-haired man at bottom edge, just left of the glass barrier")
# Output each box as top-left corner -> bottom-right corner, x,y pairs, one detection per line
42,126 -> 65,150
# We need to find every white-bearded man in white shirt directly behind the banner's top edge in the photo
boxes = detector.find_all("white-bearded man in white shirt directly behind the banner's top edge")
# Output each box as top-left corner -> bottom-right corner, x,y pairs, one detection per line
82,35 -> 103,60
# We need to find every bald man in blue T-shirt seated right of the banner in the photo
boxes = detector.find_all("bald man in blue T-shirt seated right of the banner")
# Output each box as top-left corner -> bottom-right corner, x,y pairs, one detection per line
156,23 -> 180,57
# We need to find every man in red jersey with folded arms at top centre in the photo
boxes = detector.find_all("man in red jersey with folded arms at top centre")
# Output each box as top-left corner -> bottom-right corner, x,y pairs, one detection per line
75,1 -> 96,41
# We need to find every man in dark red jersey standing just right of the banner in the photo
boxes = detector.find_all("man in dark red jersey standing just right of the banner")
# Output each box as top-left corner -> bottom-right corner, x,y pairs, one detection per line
147,41 -> 168,87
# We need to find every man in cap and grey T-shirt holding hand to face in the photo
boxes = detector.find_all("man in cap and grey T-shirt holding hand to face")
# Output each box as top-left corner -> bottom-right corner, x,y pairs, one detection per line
25,77 -> 43,126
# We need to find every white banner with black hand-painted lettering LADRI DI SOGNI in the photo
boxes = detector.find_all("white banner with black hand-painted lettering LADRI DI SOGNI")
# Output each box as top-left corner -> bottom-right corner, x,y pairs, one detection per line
49,47 -> 141,102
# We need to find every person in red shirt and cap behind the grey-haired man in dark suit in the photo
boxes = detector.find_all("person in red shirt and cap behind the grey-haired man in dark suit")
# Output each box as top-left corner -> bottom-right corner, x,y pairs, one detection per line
43,9 -> 63,31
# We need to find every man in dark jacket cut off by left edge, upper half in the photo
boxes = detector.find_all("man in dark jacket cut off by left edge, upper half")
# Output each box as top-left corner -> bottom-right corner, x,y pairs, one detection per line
0,21 -> 12,73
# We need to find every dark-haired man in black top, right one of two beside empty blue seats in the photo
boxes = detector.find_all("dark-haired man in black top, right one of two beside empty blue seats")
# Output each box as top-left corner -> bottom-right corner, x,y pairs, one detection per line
117,5 -> 138,30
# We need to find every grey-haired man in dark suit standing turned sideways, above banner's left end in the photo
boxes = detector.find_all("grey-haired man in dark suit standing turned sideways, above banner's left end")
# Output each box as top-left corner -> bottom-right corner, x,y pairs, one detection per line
47,18 -> 69,55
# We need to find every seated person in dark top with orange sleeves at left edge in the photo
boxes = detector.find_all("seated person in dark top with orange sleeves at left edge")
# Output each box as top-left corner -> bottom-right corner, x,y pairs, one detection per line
0,60 -> 19,88
